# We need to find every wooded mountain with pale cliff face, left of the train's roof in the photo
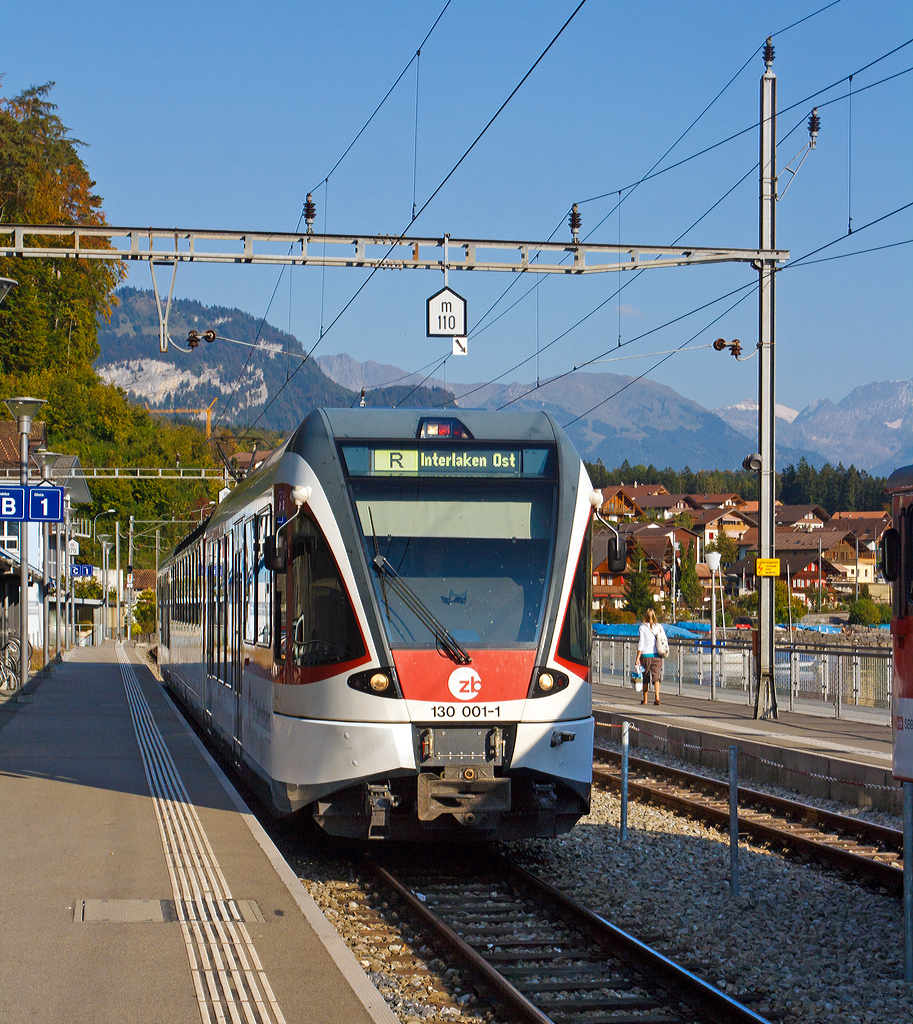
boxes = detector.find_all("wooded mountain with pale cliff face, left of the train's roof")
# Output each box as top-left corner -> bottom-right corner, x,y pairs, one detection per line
95,288 -> 449,431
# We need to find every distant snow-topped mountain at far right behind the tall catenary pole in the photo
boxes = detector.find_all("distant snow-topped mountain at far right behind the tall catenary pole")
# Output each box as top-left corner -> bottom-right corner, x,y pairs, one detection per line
715,380 -> 913,475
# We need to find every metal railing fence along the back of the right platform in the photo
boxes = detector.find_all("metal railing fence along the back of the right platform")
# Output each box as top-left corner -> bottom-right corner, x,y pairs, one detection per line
592,637 -> 894,724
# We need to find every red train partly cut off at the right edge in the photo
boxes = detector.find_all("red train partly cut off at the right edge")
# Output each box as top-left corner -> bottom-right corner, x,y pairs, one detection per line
881,466 -> 913,781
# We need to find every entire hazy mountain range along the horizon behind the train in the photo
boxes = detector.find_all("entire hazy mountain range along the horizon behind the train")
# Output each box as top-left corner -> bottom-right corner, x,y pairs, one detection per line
95,288 -> 913,474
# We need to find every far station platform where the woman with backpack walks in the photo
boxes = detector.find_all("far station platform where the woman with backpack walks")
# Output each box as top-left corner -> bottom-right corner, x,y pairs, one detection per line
593,683 -> 903,815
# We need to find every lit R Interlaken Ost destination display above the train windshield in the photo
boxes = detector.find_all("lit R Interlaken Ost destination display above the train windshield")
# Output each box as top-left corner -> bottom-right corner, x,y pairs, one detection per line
343,444 -> 554,477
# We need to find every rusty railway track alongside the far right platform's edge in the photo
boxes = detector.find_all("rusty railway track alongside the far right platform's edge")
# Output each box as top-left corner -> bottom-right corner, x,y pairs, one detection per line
593,746 -> 904,893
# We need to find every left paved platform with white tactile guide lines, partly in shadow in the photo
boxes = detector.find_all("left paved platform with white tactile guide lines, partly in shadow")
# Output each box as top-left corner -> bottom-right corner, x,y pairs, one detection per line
0,643 -> 397,1024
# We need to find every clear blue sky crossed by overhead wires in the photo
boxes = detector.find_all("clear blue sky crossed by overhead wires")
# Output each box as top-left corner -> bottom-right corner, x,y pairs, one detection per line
0,0 -> 913,409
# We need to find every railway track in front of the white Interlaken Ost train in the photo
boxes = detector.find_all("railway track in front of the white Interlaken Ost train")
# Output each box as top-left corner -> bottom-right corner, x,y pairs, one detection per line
364,851 -> 764,1024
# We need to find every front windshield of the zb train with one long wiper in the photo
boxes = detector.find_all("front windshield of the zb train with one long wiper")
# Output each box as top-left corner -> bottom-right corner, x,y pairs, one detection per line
346,449 -> 556,648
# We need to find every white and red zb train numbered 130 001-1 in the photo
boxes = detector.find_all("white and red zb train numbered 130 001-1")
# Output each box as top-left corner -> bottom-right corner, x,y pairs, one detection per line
158,409 -> 623,841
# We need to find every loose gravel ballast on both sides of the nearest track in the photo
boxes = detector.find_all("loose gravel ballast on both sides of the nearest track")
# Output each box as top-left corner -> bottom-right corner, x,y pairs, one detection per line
297,774 -> 913,1024
